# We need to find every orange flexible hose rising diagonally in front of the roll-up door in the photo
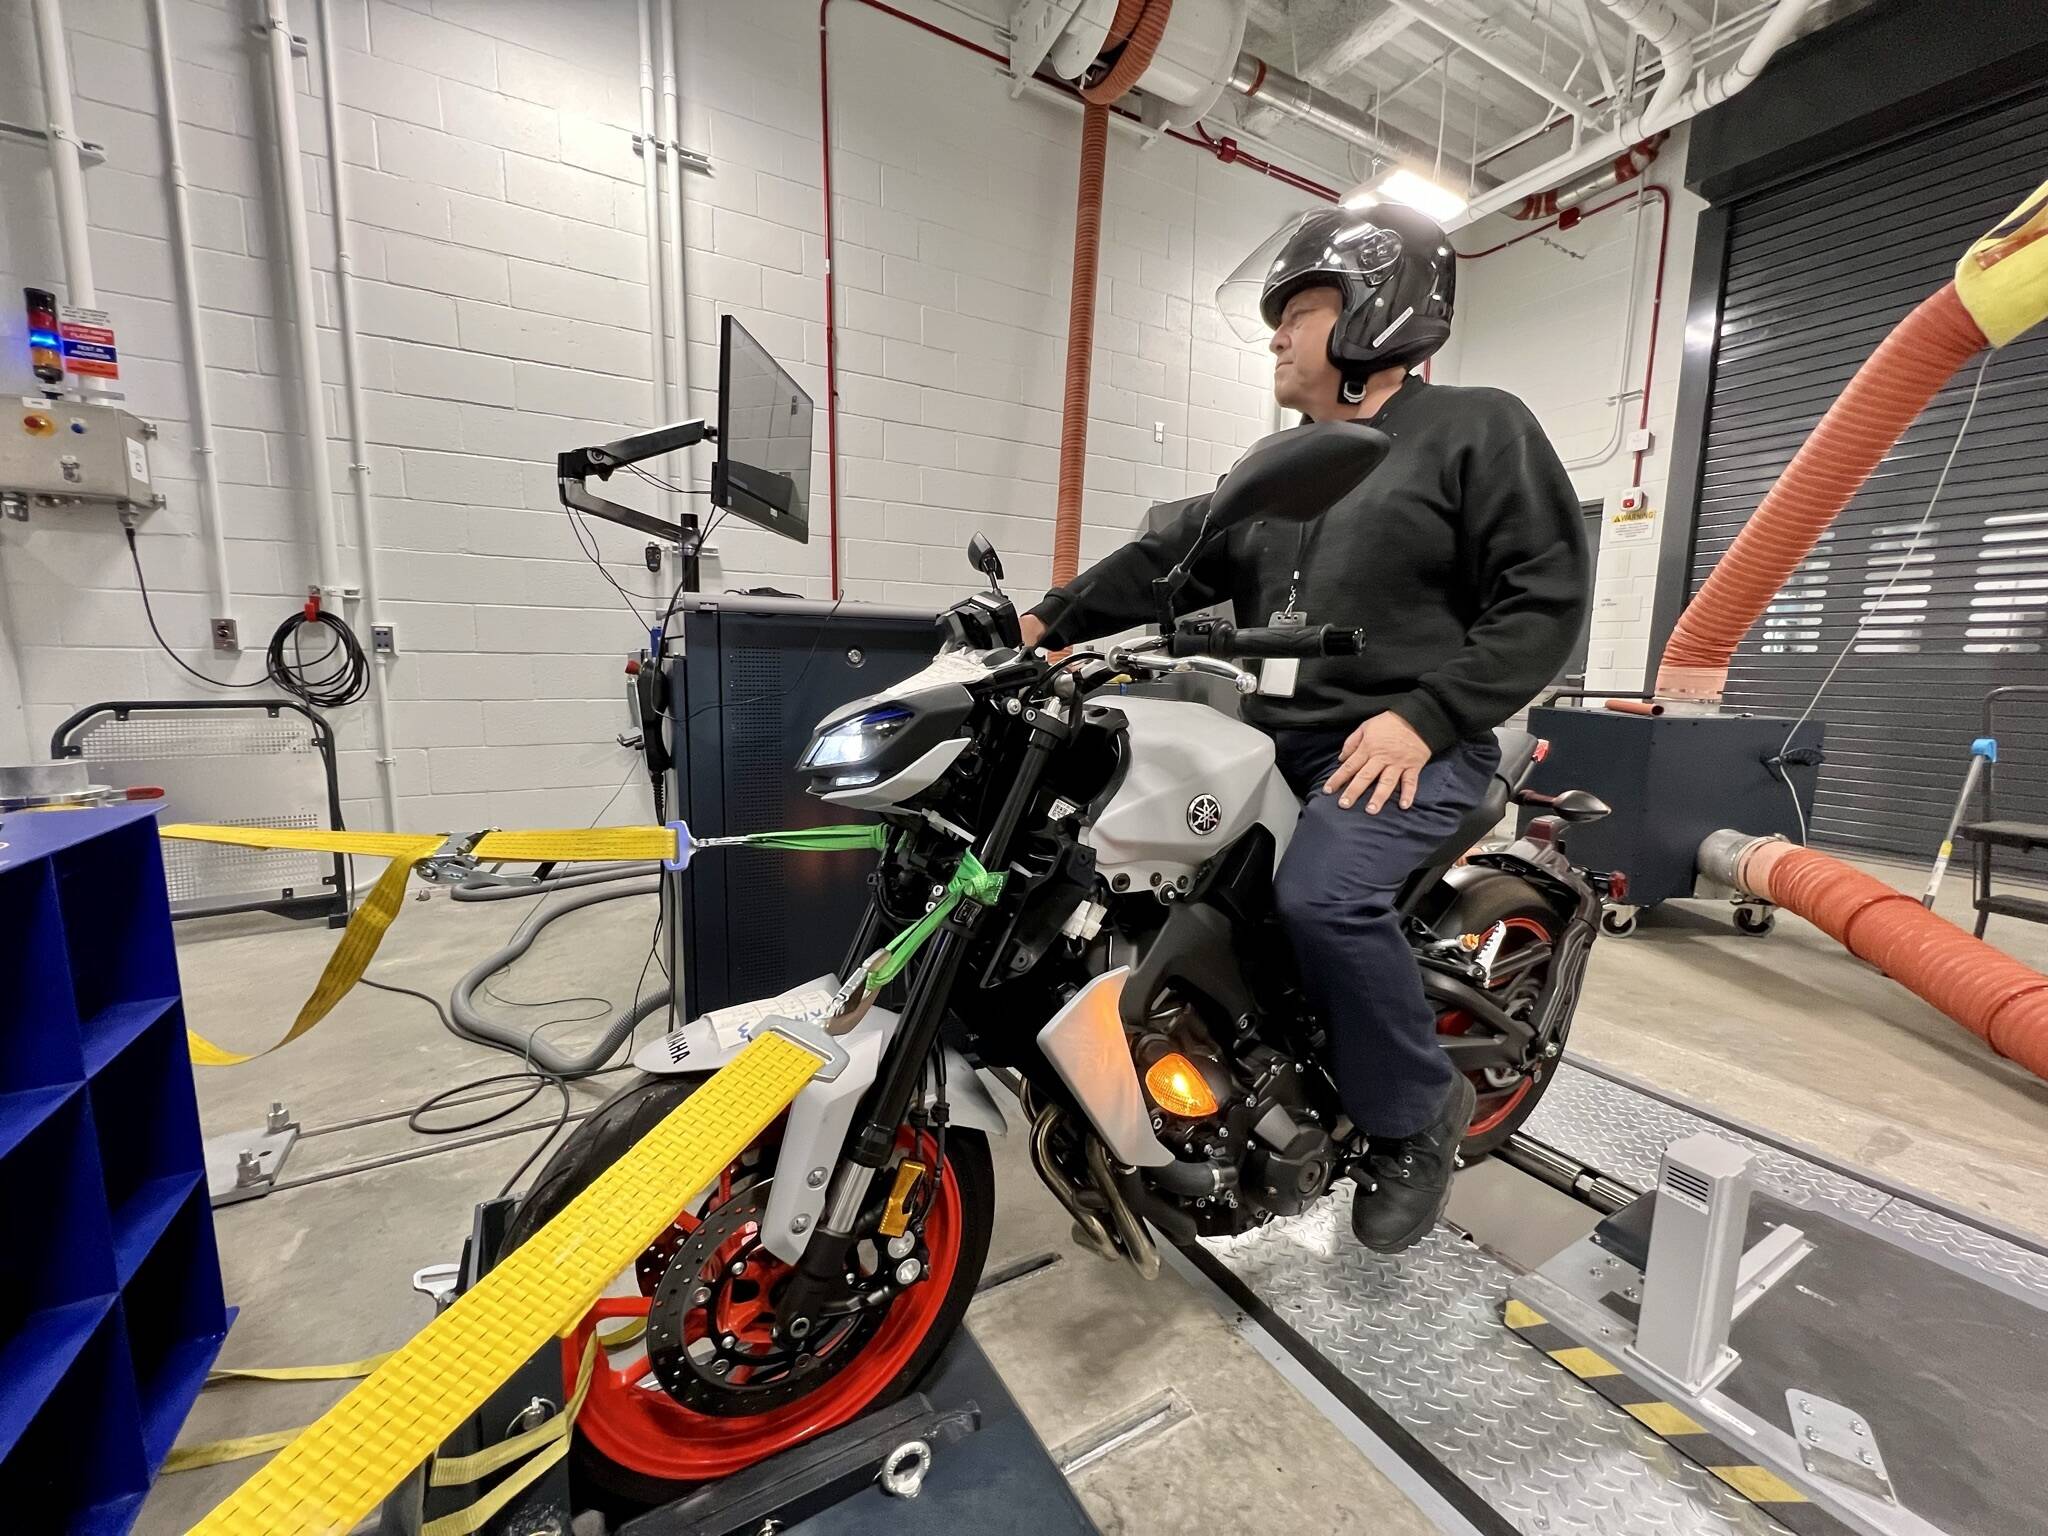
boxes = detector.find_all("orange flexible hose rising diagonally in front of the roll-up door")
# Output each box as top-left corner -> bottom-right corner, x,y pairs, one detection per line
1657,283 -> 1985,702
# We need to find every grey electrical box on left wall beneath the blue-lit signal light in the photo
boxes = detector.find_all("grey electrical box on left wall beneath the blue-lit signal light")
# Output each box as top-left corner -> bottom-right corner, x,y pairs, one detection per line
0,395 -> 160,518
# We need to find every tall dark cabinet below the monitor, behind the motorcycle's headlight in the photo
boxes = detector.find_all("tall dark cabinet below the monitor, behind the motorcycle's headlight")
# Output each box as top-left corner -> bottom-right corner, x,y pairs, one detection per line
668,592 -> 940,1018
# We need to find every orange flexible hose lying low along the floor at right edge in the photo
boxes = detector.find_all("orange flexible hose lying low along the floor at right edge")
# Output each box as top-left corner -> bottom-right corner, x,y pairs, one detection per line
1700,831 -> 2048,1077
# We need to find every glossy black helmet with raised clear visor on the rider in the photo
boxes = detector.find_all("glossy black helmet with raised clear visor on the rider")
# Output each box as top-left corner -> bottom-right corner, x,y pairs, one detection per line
1217,203 -> 1458,403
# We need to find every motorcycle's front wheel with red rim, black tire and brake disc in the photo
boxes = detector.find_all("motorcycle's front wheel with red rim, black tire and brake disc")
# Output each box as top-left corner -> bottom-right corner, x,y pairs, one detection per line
506,1077 -> 995,1516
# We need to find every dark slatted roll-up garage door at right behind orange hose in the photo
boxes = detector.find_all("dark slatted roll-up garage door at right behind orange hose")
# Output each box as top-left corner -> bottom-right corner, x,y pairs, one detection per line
1692,92 -> 2048,860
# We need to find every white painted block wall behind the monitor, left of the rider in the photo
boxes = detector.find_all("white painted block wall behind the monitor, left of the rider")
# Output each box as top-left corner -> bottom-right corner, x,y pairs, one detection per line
0,0 -> 1307,829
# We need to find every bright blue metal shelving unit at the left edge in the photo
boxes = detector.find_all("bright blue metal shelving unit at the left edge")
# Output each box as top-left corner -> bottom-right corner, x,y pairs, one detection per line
0,805 -> 229,1532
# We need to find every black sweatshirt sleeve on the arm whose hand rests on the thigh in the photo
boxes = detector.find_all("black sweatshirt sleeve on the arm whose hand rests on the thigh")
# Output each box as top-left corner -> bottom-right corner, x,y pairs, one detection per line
1389,416 -> 1589,752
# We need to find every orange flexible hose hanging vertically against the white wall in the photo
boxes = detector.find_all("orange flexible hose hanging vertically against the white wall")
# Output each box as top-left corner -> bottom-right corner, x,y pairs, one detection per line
1053,0 -> 1174,586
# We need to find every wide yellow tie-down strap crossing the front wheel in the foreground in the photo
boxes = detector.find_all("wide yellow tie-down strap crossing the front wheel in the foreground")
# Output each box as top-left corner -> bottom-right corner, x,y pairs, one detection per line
193,1034 -> 825,1536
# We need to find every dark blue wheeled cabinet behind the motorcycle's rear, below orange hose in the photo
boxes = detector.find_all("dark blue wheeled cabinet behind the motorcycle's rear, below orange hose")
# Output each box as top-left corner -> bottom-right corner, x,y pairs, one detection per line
1520,709 -> 1821,907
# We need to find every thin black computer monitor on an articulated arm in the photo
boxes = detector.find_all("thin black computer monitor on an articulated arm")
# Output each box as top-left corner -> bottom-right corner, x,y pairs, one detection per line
711,315 -> 811,545
